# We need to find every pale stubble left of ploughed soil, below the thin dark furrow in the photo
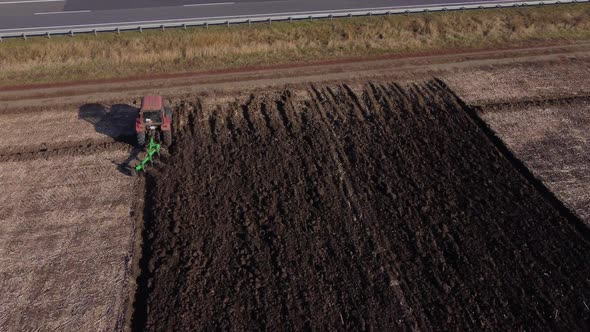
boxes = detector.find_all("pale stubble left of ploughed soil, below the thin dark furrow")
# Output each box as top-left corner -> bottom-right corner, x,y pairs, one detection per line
0,150 -> 140,331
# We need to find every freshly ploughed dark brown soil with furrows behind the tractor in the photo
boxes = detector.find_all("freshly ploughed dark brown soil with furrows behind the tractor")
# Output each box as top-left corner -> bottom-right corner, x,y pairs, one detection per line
134,82 -> 590,331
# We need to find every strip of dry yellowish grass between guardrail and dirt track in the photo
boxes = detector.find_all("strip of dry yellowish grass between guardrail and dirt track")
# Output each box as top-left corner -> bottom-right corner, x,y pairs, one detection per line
0,4 -> 590,86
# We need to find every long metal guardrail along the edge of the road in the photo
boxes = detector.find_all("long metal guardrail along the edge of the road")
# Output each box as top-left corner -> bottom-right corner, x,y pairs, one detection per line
0,0 -> 590,42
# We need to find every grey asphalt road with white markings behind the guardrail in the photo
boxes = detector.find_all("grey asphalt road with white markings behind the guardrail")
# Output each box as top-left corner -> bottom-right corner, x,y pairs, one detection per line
0,0 -> 580,35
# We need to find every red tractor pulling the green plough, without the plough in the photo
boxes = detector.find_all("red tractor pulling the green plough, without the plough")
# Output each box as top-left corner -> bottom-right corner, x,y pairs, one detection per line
135,96 -> 172,146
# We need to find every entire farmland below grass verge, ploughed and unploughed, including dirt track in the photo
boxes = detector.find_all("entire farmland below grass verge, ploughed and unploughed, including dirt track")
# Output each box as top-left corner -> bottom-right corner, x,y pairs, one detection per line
0,46 -> 590,331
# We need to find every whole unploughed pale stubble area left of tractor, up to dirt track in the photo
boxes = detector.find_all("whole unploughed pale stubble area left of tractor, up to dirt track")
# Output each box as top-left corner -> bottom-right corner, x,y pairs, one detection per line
0,105 -> 143,331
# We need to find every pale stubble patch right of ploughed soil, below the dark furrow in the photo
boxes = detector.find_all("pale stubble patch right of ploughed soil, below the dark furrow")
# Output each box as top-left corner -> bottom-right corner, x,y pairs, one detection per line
481,98 -> 590,226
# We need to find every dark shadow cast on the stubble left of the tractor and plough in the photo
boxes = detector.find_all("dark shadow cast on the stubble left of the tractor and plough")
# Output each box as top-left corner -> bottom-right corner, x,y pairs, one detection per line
78,103 -> 141,175
